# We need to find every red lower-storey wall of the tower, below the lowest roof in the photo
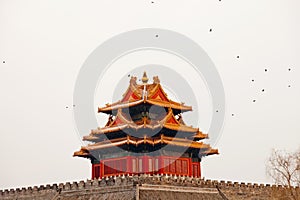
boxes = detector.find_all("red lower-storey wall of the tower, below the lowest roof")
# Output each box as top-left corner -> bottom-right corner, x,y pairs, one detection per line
92,156 -> 201,179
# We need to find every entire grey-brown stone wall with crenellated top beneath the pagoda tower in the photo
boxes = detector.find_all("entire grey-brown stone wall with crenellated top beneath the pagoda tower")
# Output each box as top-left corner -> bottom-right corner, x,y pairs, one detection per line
0,175 -> 300,200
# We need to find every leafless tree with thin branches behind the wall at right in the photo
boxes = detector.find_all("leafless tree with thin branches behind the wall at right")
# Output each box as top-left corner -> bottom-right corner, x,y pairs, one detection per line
266,149 -> 300,199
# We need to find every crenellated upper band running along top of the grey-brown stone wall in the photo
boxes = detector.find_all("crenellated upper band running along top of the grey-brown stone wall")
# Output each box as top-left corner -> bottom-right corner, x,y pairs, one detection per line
0,174 -> 300,199
